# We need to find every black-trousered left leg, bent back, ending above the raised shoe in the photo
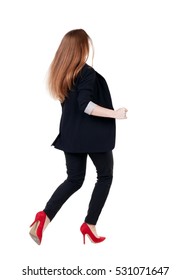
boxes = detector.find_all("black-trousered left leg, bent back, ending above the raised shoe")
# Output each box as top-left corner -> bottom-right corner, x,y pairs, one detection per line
43,153 -> 87,221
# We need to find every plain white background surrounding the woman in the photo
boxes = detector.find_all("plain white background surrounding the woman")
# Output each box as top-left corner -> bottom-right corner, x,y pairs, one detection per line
0,0 -> 190,280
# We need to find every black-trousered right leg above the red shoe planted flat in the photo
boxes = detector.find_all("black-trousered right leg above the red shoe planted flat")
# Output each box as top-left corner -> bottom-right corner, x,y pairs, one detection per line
85,151 -> 113,225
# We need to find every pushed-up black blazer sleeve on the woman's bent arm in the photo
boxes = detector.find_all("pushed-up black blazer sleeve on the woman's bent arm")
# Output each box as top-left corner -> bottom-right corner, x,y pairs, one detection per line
77,65 -> 96,112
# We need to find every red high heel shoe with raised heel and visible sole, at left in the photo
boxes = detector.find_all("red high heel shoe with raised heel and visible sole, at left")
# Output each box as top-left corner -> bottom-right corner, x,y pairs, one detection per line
29,211 -> 50,245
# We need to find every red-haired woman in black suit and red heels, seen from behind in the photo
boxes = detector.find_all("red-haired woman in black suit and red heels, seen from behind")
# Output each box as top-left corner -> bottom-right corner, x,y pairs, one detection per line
30,29 -> 127,244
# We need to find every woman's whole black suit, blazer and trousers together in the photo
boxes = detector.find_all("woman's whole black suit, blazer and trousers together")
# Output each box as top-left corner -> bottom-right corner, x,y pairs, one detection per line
44,64 -> 115,225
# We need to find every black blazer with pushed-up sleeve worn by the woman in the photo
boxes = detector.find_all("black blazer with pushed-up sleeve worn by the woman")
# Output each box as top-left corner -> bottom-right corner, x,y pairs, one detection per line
52,64 -> 115,153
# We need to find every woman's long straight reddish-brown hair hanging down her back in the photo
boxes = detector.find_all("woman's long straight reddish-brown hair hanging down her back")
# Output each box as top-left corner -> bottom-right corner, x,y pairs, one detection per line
48,29 -> 93,102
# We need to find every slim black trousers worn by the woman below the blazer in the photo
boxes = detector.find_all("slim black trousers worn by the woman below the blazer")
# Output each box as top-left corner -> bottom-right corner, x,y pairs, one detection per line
44,151 -> 113,225
